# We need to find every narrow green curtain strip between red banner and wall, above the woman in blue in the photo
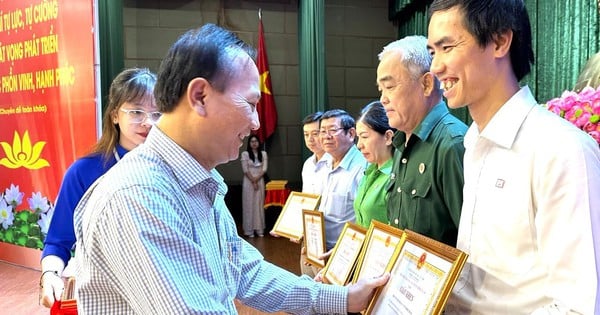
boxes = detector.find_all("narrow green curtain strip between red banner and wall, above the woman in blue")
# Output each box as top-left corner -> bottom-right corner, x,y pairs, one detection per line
98,0 -> 124,112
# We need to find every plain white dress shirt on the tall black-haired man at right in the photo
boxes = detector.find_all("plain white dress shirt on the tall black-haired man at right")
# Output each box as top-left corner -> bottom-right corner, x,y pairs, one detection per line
446,87 -> 600,314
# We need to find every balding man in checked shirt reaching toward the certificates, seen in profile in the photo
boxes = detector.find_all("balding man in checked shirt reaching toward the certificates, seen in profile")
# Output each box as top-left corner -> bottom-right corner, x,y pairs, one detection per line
75,24 -> 389,315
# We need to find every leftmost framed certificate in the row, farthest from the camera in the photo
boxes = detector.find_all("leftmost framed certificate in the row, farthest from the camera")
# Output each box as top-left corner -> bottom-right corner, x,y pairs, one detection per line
273,191 -> 321,239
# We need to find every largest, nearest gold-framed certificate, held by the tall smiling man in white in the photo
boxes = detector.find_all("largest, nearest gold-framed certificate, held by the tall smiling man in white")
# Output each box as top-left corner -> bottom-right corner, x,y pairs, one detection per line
366,230 -> 467,314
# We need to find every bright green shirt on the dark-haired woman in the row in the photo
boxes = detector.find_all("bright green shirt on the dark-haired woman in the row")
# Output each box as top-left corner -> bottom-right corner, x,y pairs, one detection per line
354,159 -> 392,228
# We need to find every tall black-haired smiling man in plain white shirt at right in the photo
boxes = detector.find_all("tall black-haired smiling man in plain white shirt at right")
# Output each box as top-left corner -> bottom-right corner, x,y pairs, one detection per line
428,0 -> 600,314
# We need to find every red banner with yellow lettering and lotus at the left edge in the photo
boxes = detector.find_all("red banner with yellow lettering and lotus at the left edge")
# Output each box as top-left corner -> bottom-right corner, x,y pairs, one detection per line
0,0 -> 97,256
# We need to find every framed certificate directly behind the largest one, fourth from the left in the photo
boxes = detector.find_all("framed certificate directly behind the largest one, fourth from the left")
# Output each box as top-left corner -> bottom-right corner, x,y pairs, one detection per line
352,220 -> 406,283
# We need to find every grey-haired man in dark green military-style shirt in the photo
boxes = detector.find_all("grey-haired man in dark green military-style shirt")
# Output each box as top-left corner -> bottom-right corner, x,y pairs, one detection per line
377,36 -> 467,246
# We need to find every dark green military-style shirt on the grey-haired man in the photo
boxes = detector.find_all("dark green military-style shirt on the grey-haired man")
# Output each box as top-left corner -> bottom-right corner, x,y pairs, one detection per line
387,102 -> 467,246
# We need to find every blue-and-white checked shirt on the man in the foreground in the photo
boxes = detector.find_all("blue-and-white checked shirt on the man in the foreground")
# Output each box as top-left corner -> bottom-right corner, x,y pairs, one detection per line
75,127 -> 348,314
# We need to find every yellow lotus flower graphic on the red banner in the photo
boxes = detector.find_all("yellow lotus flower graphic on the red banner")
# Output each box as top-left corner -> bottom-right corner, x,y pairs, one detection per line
0,130 -> 50,170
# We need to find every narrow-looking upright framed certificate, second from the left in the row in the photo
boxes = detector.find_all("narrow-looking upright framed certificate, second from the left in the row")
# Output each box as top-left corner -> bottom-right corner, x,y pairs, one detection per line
302,210 -> 325,268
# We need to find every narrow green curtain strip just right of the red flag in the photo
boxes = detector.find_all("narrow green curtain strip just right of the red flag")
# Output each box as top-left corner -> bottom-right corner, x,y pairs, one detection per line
298,0 -> 327,158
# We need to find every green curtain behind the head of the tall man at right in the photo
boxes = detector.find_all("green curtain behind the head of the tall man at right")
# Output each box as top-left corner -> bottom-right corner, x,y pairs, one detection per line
389,0 -> 600,124
